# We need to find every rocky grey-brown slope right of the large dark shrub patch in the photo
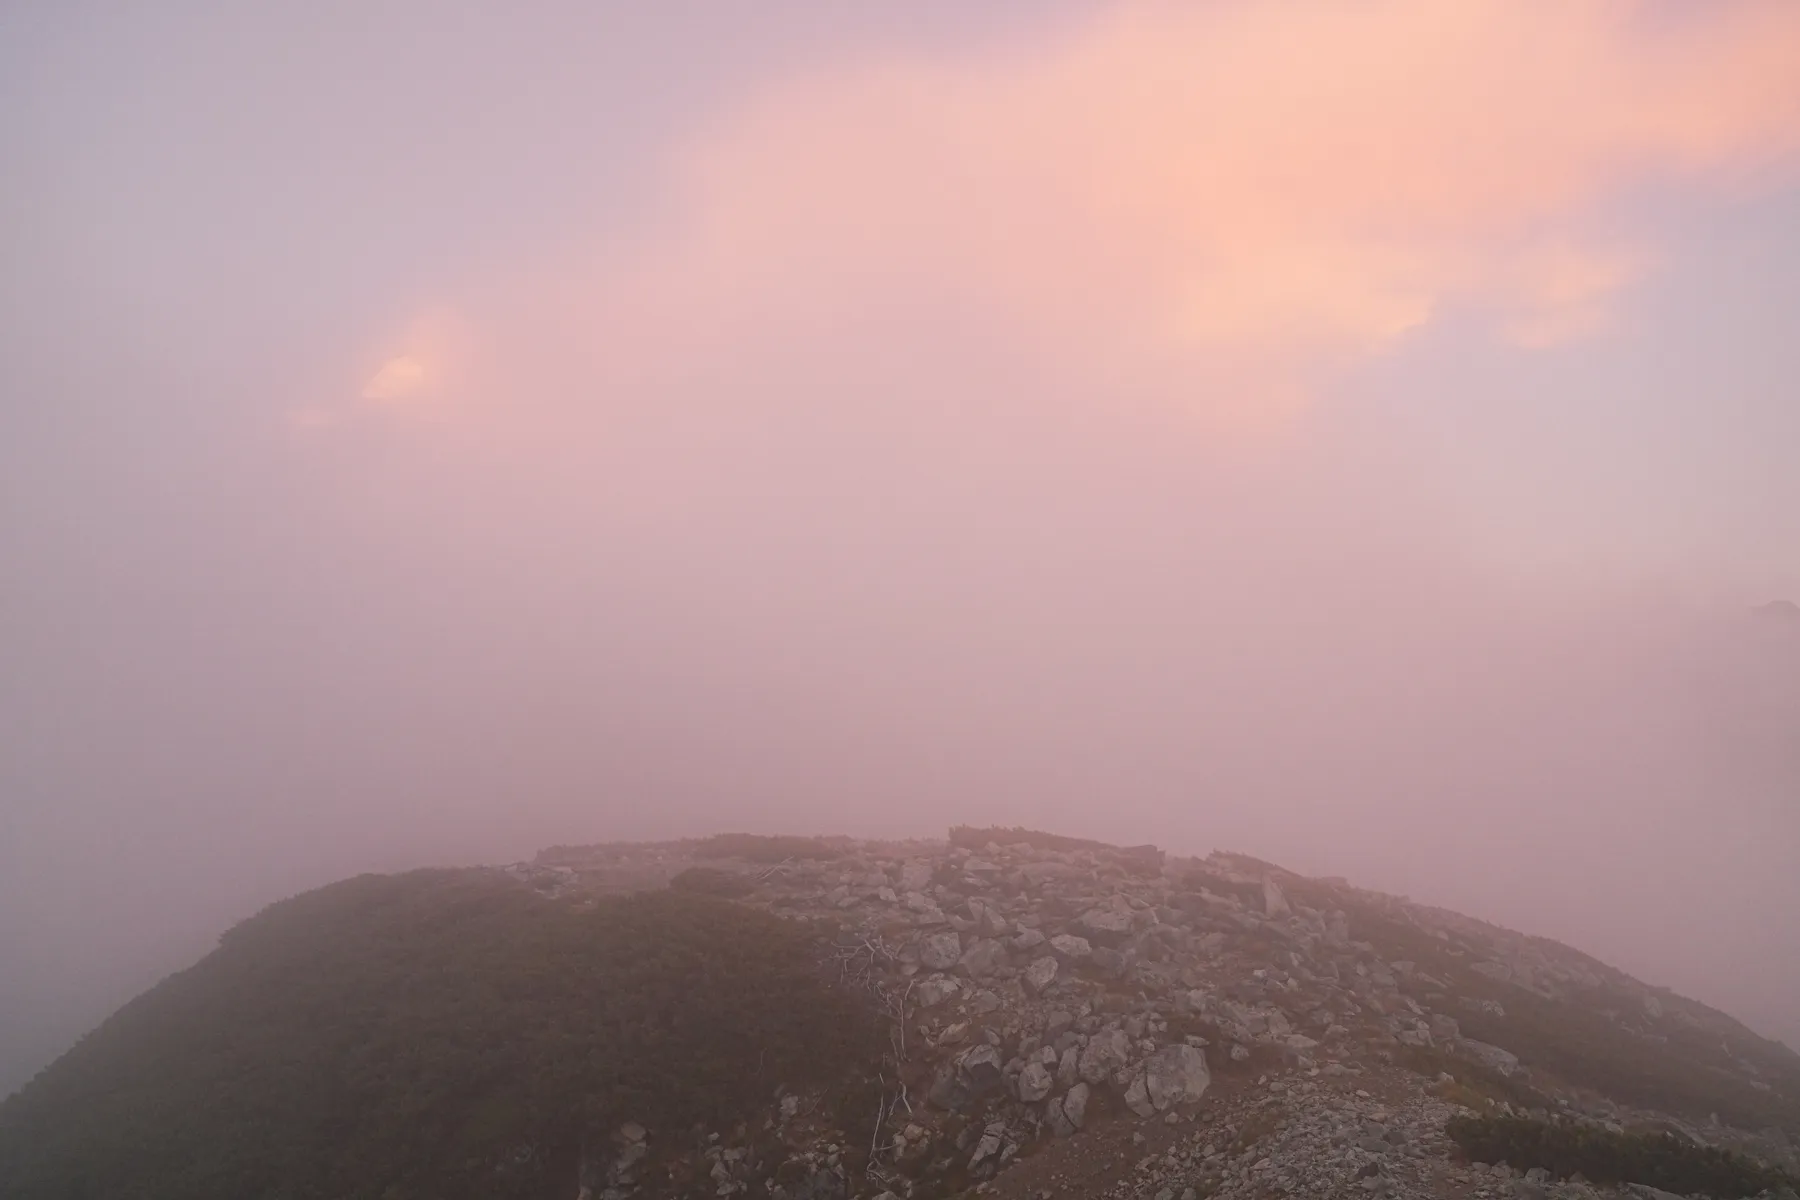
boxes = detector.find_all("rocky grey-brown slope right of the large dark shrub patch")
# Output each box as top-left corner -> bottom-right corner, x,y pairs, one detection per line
532,829 -> 1800,1200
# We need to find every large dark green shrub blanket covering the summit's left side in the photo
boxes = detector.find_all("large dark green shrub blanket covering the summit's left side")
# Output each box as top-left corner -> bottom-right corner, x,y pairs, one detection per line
0,871 -> 884,1200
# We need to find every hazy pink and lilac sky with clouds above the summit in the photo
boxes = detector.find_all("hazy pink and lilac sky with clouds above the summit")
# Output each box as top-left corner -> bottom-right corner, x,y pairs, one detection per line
0,0 -> 1800,1092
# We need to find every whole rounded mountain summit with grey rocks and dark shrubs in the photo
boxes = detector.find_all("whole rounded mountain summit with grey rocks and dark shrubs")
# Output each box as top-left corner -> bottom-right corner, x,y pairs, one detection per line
0,828 -> 1800,1200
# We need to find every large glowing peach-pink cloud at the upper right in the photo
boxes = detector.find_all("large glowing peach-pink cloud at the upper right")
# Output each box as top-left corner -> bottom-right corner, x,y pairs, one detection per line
547,0 -> 1800,419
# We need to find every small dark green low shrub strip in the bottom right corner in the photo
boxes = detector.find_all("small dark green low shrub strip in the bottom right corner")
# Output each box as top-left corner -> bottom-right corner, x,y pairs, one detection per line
1447,1117 -> 1800,1200
